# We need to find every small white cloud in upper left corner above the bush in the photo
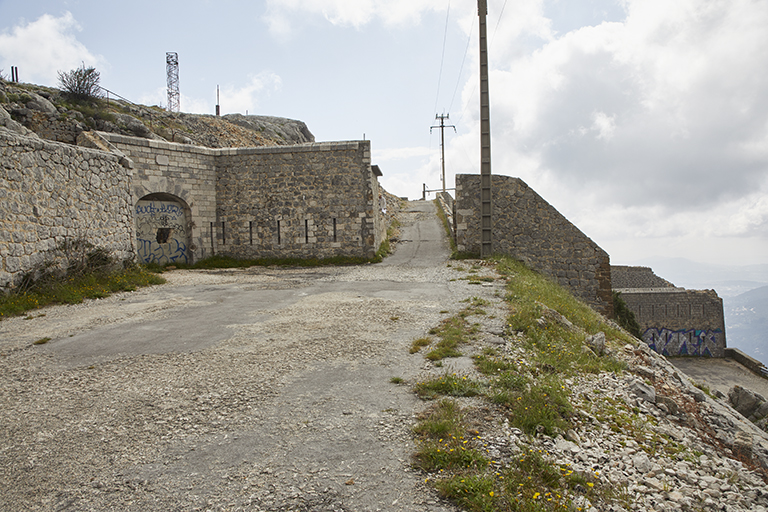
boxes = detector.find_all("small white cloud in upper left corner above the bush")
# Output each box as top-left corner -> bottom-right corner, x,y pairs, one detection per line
0,12 -> 105,86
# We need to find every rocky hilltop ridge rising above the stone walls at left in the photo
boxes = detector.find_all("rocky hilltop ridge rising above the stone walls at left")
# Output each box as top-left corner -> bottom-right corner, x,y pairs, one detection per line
0,80 -> 315,148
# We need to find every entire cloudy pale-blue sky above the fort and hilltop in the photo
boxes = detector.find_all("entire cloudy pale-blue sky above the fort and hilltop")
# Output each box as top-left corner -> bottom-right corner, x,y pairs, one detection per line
0,0 -> 768,265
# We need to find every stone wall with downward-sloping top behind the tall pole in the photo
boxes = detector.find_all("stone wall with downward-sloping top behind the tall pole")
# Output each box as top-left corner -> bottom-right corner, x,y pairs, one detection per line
454,174 -> 613,316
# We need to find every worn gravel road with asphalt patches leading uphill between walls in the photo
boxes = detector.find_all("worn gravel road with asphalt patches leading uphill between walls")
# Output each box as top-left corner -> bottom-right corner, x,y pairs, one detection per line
0,202 -> 502,511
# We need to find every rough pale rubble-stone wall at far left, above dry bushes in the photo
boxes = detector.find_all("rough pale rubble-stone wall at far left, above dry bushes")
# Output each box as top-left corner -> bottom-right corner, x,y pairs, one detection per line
0,128 -> 135,287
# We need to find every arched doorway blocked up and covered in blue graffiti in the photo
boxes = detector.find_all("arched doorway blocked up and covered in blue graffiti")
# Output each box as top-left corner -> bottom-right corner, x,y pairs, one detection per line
134,194 -> 191,264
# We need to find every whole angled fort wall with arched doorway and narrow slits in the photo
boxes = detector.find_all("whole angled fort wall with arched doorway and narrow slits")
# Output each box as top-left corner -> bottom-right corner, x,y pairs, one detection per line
100,133 -> 387,263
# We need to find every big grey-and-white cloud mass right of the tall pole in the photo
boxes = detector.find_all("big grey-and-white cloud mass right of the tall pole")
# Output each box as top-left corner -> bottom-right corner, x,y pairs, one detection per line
473,0 -> 768,213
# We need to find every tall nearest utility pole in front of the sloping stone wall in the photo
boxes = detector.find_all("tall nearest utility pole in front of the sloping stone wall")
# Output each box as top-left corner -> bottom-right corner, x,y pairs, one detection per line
477,0 -> 493,258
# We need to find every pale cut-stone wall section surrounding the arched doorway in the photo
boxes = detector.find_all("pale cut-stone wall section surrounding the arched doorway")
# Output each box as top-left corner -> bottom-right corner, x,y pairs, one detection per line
99,132 -> 220,263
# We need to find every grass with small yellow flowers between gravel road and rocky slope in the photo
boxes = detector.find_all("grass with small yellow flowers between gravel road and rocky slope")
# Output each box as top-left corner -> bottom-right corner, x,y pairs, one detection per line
410,257 -> 633,511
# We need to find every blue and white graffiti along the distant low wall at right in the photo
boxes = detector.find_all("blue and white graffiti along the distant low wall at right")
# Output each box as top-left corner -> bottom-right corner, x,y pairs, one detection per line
643,327 -> 725,357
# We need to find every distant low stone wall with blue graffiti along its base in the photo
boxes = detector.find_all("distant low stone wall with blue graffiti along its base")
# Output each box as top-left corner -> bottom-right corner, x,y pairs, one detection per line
617,287 -> 726,357
